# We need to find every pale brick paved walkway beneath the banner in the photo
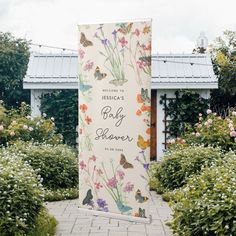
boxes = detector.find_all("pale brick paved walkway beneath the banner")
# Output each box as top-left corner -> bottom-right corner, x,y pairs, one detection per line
47,192 -> 173,236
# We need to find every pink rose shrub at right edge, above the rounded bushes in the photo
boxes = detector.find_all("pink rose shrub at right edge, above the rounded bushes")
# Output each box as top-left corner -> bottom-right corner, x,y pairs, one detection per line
184,110 -> 236,151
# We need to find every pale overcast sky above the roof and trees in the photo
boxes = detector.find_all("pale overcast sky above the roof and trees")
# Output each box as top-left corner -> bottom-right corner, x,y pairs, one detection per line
0,0 -> 236,53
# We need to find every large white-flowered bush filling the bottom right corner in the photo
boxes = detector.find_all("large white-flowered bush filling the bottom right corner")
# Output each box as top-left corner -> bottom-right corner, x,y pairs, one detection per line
171,154 -> 236,236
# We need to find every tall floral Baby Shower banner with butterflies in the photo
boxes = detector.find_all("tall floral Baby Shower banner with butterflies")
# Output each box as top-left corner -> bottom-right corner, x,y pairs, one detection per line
78,21 -> 151,221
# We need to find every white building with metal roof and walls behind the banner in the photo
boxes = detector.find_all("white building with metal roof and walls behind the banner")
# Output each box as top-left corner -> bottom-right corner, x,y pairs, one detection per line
23,53 -> 218,159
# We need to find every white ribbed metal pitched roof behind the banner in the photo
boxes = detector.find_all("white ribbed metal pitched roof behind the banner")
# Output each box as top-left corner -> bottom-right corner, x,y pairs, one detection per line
23,53 -> 218,89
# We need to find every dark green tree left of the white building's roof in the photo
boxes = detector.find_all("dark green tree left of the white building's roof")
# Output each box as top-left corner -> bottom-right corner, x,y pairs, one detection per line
0,32 -> 30,108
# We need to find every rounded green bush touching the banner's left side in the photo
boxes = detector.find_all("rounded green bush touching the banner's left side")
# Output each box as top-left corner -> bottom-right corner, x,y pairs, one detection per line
9,142 -> 79,189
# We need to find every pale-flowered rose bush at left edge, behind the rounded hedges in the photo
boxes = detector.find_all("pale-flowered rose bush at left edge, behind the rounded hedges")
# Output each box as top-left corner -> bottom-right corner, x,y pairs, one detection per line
0,103 -> 62,145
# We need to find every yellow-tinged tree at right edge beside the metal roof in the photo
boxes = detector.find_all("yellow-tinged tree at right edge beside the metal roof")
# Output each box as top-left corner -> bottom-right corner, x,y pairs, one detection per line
211,30 -> 236,114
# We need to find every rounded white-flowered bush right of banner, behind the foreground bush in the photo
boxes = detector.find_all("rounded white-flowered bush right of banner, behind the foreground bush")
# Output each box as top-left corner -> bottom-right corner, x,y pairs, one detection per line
156,146 -> 223,190
